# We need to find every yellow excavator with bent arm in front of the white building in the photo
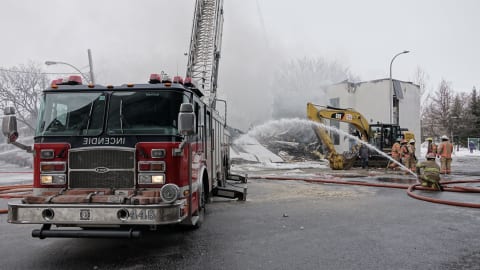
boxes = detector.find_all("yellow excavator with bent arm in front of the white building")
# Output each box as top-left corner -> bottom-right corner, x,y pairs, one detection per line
307,103 -> 415,170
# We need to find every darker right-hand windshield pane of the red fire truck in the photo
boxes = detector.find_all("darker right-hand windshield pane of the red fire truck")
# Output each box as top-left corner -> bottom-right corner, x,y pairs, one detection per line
107,90 -> 188,135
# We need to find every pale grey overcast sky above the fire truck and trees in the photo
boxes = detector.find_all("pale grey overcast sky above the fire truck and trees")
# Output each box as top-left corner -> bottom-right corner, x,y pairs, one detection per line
0,0 -> 480,131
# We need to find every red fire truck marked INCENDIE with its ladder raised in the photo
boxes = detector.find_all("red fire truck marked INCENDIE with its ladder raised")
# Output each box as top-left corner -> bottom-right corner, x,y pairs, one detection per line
2,0 -> 246,239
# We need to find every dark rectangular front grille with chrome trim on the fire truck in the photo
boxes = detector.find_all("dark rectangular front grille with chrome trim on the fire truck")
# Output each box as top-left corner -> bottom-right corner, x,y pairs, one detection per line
68,147 -> 135,189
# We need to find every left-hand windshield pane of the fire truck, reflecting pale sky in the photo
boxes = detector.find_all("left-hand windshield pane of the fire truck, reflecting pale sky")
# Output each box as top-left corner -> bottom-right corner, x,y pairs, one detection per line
35,92 -> 106,136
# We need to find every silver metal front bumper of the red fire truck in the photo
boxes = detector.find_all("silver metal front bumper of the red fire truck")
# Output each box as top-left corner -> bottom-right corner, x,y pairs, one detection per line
8,199 -> 187,227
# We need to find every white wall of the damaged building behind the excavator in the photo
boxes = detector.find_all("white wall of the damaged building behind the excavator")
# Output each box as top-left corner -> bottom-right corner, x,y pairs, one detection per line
324,79 -> 421,156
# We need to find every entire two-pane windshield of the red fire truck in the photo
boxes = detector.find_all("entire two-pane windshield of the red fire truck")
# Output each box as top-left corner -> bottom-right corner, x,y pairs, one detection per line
36,90 -> 189,136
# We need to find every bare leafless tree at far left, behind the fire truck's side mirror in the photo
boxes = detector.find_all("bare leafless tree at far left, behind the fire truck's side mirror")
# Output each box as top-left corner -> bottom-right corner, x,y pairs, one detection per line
0,63 -> 48,132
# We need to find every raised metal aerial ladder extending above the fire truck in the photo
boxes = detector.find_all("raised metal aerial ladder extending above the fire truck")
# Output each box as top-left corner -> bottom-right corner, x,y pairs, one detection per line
186,0 -> 223,108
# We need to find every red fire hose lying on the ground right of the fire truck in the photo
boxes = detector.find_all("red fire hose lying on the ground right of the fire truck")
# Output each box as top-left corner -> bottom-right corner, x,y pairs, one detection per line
249,176 -> 480,208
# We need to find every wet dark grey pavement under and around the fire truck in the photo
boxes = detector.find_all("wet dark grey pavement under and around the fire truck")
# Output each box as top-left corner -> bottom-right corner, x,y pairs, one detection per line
0,157 -> 480,269
